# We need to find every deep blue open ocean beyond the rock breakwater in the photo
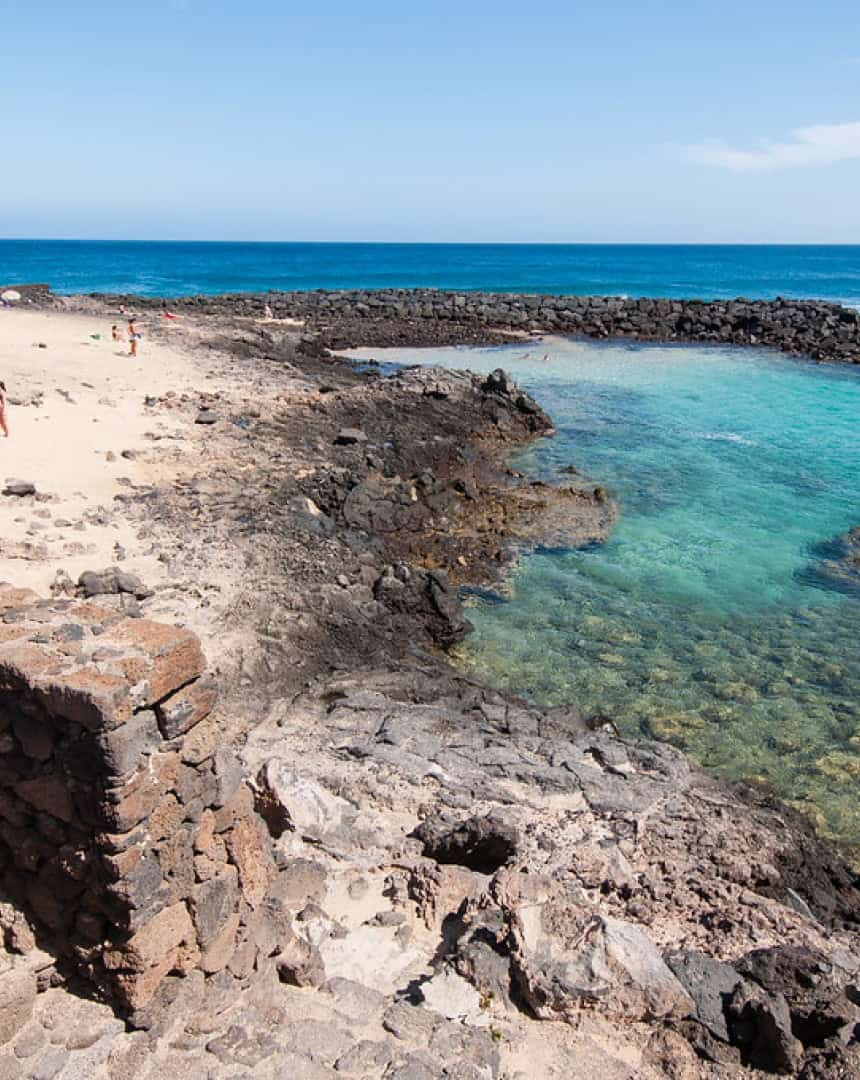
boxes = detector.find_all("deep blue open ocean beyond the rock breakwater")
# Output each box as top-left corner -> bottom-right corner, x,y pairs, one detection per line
0,240 -> 860,307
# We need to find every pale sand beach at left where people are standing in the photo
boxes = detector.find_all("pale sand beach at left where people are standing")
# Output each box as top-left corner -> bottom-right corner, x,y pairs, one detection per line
0,310 -> 200,596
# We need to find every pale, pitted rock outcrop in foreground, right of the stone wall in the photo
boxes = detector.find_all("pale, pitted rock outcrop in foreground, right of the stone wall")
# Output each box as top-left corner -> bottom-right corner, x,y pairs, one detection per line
232,660 -> 860,1080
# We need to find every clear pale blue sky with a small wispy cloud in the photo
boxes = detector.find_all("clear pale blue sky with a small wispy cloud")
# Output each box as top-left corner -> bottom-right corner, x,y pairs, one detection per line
0,0 -> 860,243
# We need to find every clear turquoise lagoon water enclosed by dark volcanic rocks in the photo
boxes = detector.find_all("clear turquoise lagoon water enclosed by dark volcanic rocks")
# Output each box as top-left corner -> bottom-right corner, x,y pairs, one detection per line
350,340 -> 860,850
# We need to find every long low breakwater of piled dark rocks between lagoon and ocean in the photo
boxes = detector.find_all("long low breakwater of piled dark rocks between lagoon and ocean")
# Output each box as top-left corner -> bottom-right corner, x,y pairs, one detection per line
74,289 -> 860,364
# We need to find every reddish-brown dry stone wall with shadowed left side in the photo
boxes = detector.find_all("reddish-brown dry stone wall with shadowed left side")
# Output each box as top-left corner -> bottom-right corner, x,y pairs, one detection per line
0,584 -> 288,1023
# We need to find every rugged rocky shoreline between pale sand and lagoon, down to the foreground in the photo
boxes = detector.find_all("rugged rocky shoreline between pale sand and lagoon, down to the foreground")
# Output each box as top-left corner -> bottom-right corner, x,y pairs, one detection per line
0,294 -> 860,1080
